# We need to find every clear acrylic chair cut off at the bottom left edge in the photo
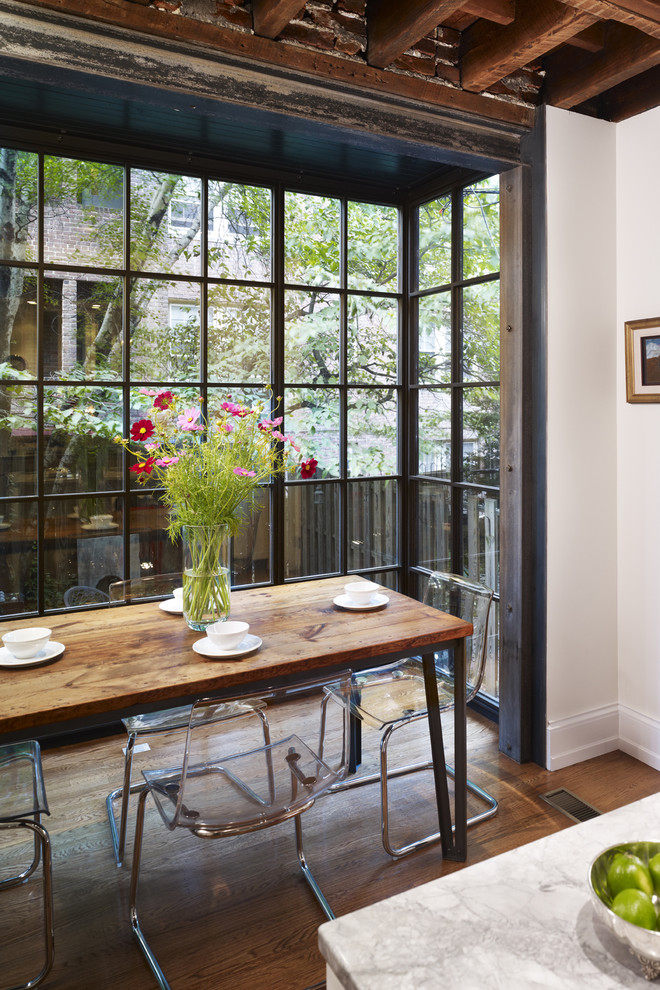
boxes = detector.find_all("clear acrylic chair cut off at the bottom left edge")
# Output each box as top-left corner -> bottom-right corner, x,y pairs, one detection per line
0,740 -> 55,990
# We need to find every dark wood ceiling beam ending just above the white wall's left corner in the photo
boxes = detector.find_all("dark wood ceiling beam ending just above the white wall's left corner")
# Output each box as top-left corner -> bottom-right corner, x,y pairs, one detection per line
544,23 -> 660,110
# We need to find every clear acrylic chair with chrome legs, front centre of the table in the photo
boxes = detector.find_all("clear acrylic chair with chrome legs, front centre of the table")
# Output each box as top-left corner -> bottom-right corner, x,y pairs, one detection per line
130,672 -> 351,990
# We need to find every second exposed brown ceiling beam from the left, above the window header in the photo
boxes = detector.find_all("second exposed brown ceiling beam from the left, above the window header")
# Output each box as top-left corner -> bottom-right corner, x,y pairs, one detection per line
367,0 -> 465,69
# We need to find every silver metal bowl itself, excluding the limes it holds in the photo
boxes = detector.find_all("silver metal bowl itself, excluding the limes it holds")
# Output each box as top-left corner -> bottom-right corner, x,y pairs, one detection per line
589,842 -> 660,980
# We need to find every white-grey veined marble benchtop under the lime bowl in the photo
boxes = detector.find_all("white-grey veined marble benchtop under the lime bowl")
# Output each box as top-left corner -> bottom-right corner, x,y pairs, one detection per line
319,795 -> 660,990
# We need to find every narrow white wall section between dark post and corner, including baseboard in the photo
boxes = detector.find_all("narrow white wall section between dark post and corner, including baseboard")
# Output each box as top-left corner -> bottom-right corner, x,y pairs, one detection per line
546,107 -> 620,769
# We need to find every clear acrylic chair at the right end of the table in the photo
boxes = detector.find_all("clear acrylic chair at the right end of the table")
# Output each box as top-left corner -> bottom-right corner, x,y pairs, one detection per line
333,571 -> 497,858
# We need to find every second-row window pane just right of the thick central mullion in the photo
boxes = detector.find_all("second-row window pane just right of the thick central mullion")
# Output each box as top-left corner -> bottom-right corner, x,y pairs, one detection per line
284,291 -> 340,384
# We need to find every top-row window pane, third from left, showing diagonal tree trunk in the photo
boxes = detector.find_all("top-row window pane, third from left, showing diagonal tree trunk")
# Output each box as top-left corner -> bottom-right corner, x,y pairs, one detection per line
131,169 -> 202,275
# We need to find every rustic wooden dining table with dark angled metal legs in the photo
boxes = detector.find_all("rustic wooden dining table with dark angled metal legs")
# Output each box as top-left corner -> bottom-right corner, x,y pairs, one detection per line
0,577 -> 472,861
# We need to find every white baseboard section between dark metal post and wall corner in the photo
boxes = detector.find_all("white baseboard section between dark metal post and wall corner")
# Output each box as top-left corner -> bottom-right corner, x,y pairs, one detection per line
546,705 -> 623,770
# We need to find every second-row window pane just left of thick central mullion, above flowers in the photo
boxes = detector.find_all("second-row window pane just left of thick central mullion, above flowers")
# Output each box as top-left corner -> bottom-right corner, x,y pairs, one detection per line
208,285 -> 271,382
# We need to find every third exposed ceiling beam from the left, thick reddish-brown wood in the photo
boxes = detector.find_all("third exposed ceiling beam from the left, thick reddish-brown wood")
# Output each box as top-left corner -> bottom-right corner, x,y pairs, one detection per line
461,0 -> 596,92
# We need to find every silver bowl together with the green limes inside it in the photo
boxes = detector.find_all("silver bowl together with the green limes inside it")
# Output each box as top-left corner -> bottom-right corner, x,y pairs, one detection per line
589,842 -> 660,980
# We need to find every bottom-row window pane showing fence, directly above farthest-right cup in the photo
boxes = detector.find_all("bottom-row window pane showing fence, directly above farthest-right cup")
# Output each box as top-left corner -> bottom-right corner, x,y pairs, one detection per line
346,479 -> 399,571
